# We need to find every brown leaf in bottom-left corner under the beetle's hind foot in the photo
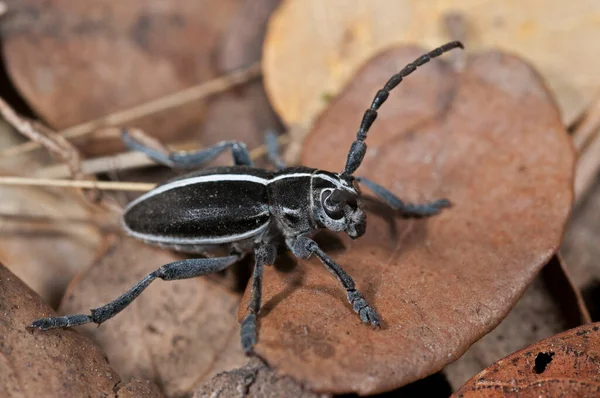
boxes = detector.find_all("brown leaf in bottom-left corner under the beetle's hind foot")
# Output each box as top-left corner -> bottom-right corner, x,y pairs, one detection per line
0,265 -> 119,398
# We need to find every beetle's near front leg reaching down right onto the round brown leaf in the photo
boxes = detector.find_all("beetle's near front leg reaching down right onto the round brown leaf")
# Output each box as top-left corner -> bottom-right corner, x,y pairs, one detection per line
288,237 -> 379,326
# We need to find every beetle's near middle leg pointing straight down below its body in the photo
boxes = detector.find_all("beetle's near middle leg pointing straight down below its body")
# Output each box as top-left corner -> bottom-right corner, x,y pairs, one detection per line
241,244 -> 277,354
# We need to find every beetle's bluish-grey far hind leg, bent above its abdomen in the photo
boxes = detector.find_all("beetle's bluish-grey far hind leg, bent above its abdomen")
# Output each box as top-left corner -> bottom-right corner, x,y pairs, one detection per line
121,129 -> 252,168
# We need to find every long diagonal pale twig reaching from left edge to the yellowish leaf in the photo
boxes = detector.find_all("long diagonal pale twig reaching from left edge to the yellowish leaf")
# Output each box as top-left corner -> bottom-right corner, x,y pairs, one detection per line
0,63 -> 260,156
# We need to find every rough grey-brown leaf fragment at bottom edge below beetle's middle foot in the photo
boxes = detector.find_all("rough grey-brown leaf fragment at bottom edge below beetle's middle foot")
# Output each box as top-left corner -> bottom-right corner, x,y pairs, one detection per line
194,358 -> 331,398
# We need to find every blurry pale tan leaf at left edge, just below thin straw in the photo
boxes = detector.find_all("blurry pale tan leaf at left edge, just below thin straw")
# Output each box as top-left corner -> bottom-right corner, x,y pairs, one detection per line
0,186 -> 101,306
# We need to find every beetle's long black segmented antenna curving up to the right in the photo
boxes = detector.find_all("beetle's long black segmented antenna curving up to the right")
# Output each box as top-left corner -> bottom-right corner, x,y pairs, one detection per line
342,41 -> 464,175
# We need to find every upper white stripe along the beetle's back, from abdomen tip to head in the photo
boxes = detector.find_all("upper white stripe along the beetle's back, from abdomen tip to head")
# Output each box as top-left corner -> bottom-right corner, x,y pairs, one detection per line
125,173 -> 355,211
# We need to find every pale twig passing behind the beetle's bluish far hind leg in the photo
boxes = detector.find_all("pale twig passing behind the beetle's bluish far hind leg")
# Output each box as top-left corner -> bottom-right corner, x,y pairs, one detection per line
34,135 -> 289,178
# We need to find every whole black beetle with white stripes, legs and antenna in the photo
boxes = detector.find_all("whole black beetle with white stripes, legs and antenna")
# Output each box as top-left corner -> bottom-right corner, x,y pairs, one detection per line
29,41 -> 463,353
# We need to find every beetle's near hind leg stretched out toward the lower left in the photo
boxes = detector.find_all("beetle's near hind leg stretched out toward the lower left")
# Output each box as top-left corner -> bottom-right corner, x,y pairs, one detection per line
29,256 -> 240,330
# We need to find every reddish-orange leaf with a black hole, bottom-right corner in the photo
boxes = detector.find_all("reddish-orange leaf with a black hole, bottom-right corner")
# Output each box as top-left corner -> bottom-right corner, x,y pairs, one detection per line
452,323 -> 600,398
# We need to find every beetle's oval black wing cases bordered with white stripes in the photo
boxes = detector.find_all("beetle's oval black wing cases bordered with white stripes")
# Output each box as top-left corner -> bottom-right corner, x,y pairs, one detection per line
122,174 -> 270,245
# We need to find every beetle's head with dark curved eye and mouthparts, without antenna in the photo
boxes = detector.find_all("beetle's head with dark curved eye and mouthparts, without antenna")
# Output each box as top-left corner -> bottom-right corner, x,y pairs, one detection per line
313,172 -> 367,239
